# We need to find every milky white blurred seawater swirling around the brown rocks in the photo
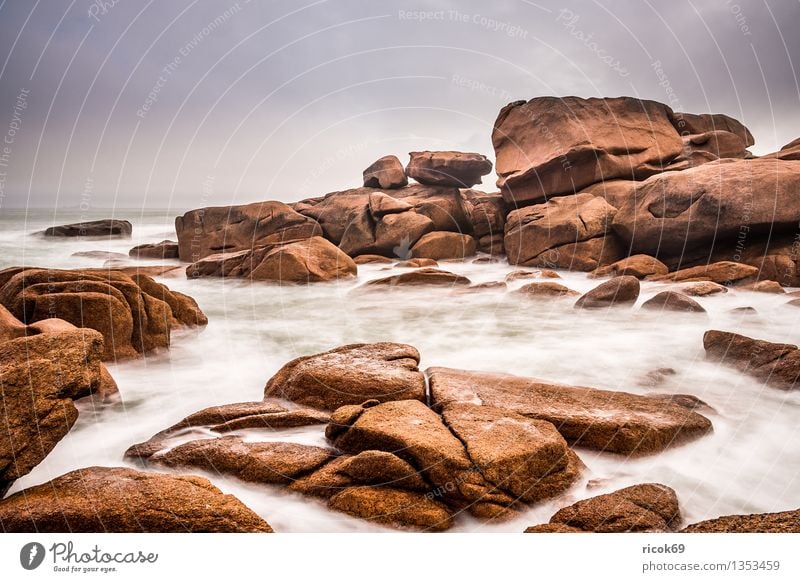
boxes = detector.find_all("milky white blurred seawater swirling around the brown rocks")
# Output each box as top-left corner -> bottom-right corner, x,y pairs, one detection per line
0,210 -> 800,532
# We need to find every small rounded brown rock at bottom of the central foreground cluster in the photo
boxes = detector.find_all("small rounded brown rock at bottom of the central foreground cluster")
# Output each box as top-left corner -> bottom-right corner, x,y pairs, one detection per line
328,487 -> 453,531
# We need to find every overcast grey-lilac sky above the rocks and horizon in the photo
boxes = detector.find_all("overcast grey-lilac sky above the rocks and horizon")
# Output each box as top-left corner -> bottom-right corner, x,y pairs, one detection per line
0,0 -> 800,212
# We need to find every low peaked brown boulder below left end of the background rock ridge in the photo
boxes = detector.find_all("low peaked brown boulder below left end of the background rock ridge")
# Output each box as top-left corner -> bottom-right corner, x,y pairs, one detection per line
186,236 -> 358,283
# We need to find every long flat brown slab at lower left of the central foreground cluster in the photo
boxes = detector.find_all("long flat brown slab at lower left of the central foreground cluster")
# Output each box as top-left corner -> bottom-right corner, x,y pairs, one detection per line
149,436 -> 333,485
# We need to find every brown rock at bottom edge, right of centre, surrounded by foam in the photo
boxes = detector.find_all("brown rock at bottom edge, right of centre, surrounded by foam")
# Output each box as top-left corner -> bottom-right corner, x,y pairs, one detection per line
537,483 -> 681,533
